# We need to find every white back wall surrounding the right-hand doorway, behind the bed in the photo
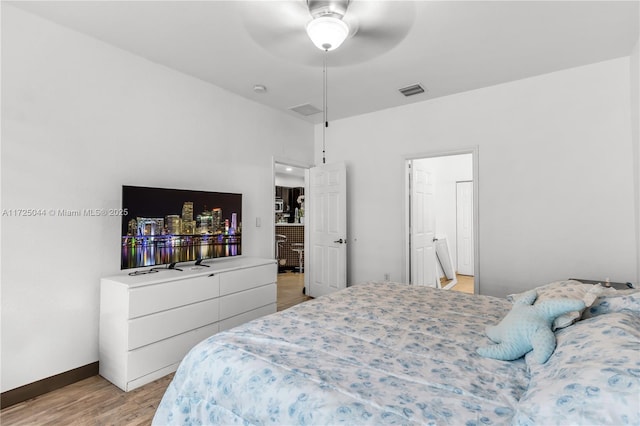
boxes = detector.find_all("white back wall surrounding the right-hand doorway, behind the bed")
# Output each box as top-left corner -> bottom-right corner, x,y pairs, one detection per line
315,57 -> 638,296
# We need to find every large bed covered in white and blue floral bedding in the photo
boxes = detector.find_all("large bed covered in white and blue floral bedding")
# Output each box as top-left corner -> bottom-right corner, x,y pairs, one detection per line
153,282 -> 640,425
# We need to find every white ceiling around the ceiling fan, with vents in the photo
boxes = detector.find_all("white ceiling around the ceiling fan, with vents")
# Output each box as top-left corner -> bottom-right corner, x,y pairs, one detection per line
3,0 -> 640,123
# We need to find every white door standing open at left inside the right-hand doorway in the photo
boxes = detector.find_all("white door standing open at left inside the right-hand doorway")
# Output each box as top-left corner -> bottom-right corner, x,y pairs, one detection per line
409,161 -> 439,287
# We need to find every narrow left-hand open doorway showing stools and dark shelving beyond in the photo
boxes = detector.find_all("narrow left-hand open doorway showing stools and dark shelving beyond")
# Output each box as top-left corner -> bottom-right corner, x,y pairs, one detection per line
274,161 -> 308,311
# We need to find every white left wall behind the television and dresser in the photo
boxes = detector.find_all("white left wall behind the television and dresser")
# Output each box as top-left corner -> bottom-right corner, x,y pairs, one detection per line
1,4 -> 313,391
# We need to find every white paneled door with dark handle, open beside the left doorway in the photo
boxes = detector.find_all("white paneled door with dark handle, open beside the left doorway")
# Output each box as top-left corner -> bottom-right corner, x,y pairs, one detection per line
305,163 -> 347,297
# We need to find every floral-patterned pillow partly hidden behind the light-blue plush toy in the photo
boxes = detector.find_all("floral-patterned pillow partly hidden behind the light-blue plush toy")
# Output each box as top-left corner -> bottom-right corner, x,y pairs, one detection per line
507,280 -> 604,331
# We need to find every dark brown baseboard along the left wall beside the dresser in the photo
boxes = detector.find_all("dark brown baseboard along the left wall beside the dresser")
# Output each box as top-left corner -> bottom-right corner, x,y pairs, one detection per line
0,361 -> 99,409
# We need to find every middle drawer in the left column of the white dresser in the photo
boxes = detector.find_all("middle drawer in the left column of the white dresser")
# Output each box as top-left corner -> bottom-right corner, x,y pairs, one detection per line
128,298 -> 220,350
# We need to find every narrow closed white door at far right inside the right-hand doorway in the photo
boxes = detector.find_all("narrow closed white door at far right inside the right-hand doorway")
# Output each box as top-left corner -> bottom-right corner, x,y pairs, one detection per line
456,181 -> 474,275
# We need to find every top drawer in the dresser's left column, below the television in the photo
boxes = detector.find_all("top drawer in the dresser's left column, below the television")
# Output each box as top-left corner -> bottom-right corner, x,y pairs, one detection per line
129,275 -> 220,318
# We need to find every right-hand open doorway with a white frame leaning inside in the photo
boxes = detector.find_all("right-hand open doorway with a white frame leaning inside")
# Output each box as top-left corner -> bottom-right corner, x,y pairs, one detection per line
407,150 -> 479,293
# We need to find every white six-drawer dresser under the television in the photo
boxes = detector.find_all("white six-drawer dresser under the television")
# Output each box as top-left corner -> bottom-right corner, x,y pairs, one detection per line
99,258 -> 277,391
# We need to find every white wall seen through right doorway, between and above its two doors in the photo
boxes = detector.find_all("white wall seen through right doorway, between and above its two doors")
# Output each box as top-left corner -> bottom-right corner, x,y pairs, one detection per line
416,154 -> 473,267
